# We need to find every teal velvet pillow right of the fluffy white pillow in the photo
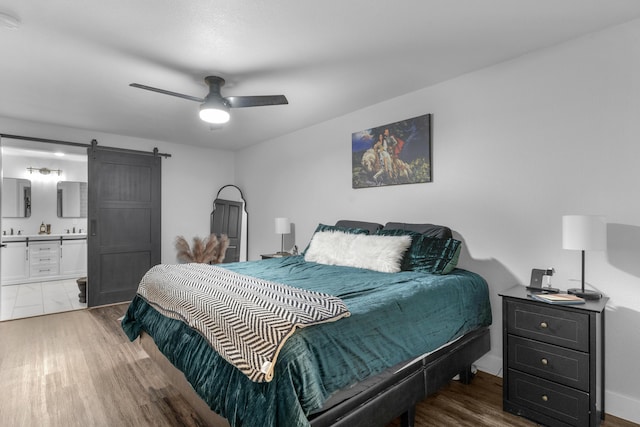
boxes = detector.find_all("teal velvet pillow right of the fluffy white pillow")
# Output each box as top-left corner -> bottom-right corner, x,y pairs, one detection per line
377,230 -> 462,274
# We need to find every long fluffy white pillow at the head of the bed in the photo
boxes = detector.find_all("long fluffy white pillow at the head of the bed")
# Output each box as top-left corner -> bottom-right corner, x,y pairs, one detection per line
304,231 -> 411,273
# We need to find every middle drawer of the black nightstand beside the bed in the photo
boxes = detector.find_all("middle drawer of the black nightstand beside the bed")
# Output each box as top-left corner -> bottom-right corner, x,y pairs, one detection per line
509,335 -> 589,392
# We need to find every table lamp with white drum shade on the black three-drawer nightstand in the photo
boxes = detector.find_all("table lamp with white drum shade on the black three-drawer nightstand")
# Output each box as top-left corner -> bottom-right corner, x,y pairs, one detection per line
562,215 -> 607,300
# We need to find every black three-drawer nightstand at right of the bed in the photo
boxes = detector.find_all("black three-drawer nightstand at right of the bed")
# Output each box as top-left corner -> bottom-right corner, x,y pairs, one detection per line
500,286 -> 609,426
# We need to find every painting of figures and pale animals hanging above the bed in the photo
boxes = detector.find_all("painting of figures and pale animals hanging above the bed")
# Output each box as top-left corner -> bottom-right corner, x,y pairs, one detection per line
351,114 -> 432,188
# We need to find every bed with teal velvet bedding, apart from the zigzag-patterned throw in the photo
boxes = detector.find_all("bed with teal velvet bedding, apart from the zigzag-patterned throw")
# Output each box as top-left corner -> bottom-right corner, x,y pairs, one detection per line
122,221 -> 491,427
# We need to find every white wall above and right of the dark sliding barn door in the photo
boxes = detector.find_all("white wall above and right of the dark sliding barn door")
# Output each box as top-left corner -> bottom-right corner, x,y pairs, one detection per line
0,118 -> 234,263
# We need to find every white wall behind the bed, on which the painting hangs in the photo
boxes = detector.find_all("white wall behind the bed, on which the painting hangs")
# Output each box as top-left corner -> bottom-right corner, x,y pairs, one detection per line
236,21 -> 640,422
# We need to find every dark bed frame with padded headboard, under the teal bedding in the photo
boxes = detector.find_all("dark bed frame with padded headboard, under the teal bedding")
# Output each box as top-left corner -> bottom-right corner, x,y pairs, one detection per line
140,221 -> 491,427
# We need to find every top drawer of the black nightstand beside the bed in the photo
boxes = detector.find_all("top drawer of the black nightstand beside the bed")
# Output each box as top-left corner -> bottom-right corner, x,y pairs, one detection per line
507,301 -> 589,352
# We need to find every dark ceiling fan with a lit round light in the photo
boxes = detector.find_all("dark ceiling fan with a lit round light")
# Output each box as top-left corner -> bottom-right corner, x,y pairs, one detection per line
129,76 -> 289,124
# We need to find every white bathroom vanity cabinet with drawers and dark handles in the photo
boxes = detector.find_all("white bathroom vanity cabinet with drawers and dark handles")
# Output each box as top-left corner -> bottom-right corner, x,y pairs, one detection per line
1,233 -> 87,286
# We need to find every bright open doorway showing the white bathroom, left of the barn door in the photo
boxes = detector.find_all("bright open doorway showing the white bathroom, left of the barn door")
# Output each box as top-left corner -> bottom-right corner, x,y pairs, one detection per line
0,138 -> 88,320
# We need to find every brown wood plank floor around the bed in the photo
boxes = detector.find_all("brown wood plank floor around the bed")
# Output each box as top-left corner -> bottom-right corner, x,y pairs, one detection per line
0,305 -> 637,427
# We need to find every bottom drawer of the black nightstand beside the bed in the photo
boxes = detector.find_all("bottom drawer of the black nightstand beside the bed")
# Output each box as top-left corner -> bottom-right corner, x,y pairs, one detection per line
508,370 -> 590,426
